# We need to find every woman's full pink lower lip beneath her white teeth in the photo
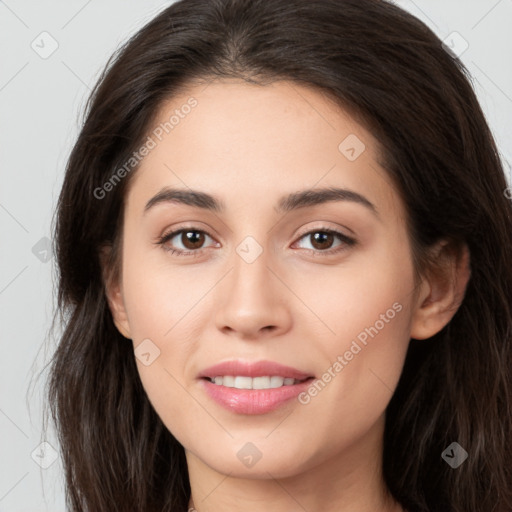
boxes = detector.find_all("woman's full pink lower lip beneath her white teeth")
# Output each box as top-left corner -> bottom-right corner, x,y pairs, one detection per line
201,377 -> 314,414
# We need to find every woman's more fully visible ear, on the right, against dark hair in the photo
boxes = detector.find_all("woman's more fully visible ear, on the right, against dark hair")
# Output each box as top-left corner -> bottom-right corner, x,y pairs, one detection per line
410,240 -> 471,340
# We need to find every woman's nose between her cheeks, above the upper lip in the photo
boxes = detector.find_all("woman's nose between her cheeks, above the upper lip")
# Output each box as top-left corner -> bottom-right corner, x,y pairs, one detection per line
214,243 -> 293,340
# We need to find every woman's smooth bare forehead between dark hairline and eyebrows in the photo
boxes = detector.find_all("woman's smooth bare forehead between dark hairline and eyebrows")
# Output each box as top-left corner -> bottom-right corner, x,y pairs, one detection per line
128,80 -> 397,220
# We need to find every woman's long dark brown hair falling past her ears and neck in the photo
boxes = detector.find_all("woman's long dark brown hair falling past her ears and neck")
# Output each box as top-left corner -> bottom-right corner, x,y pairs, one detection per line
48,0 -> 512,512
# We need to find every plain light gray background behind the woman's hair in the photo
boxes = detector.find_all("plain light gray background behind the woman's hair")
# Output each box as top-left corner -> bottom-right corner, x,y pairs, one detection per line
0,0 -> 512,512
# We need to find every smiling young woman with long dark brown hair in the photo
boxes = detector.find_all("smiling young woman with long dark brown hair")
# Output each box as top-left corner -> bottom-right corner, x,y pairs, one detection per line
45,0 -> 512,512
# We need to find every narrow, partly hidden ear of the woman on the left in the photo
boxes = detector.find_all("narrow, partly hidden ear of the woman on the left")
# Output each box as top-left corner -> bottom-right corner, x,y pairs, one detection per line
99,245 -> 131,339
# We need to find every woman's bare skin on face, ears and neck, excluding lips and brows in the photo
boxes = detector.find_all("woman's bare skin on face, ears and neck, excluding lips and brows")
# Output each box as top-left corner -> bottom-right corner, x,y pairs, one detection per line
107,80 -> 469,512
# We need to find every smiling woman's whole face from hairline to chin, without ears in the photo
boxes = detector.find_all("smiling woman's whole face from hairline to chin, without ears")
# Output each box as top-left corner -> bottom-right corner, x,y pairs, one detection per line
107,80 -> 420,478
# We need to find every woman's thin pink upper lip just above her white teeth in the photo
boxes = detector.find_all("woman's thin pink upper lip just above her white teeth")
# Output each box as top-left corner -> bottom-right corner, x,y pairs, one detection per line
198,359 -> 313,380
